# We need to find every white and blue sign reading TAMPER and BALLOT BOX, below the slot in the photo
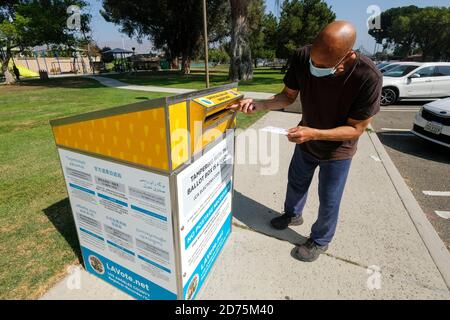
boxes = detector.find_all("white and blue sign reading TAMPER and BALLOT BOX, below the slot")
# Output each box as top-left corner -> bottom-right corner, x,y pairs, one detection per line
177,135 -> 234,300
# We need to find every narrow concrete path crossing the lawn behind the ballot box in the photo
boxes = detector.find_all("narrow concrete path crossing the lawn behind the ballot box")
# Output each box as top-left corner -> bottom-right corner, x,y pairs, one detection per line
87,76 -> 273,99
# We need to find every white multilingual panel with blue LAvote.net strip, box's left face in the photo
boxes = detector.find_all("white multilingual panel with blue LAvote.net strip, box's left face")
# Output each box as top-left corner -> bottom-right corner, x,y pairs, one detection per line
59,149 -> 177,300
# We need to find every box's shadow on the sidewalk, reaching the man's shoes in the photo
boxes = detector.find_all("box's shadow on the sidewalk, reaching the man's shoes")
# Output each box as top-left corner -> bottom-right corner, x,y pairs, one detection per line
233,192 -> 307,245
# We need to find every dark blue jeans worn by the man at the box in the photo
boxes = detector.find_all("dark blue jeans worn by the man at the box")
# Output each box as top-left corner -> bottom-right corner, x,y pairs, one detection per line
284,145 -> 352,246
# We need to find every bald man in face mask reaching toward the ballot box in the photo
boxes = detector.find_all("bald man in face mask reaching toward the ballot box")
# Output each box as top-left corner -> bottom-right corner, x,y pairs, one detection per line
231,21 -> 382,262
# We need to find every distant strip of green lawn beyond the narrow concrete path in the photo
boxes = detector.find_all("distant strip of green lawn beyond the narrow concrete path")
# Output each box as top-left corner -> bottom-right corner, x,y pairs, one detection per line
108,67 -> 284,93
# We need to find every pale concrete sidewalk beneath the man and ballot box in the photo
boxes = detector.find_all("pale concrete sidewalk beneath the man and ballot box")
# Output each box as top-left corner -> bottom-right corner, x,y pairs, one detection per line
43,112 -> 450,300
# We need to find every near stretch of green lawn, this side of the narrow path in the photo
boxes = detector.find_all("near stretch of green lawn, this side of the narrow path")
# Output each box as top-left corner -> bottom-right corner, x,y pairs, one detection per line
0,78 -> 264,299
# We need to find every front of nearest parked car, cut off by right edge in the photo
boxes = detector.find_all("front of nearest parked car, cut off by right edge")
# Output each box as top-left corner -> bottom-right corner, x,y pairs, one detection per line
412,98 -> 450,148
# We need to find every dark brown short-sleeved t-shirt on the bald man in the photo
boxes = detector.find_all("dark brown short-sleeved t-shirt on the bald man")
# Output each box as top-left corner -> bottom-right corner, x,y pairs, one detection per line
284,46 -> 383,160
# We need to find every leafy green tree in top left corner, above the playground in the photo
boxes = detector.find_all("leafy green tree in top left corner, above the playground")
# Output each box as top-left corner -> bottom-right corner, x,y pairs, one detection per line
0,0 -> 90,83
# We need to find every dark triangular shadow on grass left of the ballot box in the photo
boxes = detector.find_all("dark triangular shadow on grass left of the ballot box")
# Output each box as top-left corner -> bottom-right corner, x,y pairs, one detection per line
44,198 -> 83,263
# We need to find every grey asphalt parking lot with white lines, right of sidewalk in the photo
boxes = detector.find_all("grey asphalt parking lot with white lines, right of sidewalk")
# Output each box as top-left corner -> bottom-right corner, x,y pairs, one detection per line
372,101 -> 450,250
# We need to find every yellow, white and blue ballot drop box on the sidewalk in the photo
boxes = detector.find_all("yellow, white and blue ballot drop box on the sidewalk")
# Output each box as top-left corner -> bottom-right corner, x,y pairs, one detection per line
51,84 -> 243,300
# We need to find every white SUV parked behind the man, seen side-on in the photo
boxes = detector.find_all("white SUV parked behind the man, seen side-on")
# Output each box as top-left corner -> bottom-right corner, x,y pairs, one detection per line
381,62 -> 450,106
